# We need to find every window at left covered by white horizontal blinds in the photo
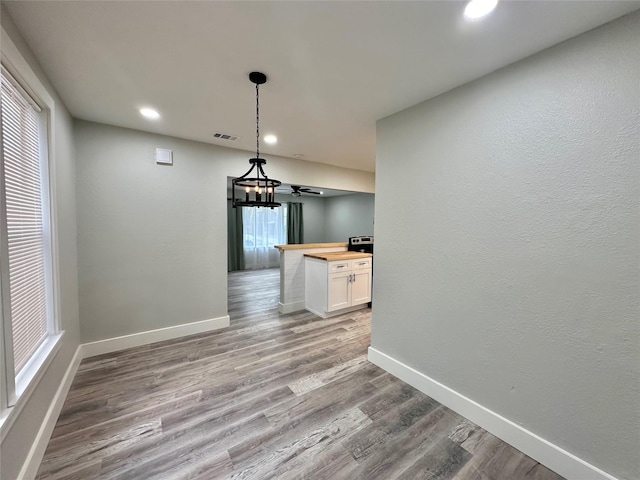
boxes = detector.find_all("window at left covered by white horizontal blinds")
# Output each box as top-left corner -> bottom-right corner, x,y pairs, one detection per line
0,65 -> 57,416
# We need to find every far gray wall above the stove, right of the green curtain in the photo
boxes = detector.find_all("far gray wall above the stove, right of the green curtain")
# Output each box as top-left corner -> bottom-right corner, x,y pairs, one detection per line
324,193 -> 374,242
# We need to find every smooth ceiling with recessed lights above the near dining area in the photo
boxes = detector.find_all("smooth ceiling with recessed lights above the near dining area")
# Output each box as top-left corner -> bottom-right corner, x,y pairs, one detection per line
3,0 -> 640,171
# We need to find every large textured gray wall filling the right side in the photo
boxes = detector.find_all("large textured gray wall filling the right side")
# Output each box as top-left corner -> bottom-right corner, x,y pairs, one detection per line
372,13 -> 640,479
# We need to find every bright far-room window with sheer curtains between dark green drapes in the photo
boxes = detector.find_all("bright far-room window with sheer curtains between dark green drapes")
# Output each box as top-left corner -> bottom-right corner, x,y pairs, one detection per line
242,204 -> 287,269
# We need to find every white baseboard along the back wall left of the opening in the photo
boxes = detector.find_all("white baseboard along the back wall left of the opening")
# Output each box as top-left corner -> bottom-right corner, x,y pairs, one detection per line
81,315 -> 229,358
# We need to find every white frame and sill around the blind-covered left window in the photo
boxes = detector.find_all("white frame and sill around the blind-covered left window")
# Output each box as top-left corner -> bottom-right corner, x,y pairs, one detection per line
0,28 -> 64,441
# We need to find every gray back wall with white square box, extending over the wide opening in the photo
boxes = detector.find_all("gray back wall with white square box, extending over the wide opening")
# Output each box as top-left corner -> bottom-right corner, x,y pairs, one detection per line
75,121 -> 374,342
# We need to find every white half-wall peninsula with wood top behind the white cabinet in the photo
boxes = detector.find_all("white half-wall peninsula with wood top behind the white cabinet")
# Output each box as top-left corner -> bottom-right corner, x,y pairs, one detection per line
275,243 -> 347,313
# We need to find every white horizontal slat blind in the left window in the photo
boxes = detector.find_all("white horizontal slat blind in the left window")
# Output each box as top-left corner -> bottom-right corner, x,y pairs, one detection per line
2,70 -> 48,375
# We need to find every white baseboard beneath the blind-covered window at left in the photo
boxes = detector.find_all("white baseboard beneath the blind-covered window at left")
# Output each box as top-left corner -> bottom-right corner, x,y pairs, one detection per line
18,346 -> 82,480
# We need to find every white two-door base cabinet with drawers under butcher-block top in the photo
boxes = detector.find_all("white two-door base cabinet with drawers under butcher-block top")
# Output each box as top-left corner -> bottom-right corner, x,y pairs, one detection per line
305,257 -> 371,318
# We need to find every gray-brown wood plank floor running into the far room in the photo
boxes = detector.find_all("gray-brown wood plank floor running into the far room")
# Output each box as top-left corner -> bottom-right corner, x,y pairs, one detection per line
38,270 -> 561,480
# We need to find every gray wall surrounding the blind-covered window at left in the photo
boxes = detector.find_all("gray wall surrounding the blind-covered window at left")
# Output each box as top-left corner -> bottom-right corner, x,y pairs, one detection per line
0,5 -> 79,479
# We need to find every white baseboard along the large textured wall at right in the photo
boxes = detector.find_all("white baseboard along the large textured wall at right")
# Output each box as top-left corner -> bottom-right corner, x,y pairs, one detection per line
369,347 -> 616,480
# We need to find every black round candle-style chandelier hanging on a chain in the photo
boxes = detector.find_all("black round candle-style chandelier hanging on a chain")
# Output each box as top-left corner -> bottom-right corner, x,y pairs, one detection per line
231,72 -> 282,208
